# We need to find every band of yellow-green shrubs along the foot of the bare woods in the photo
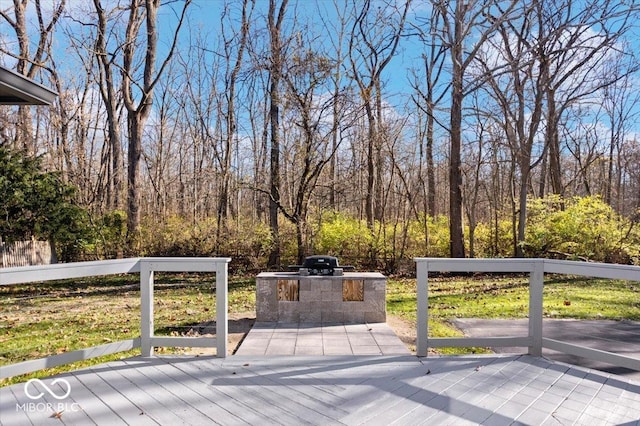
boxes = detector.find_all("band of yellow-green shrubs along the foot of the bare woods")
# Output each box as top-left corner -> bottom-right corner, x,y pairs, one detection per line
76,196 -> 640,272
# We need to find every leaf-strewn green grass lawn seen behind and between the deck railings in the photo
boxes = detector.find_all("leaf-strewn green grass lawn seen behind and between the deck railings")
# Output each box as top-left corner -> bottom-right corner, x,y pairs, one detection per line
0,274 -> 640,385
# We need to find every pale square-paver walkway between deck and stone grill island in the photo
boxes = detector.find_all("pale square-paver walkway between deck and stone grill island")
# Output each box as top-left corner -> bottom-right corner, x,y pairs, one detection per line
235,322 -> 411,356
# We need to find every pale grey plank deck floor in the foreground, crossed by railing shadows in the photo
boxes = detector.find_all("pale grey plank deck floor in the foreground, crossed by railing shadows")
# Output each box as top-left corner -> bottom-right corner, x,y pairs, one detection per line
0,355 -> 640,425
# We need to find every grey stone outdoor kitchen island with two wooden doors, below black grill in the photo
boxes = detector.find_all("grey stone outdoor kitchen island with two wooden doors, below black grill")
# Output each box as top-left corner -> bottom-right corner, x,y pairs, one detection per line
256,272 -> 387,323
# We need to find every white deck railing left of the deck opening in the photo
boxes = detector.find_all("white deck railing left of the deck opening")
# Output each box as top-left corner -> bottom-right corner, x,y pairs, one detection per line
0,257 -> 231,379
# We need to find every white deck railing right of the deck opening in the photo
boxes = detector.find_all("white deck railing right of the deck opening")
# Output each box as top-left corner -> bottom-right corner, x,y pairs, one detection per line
414,258 -> 640,371
